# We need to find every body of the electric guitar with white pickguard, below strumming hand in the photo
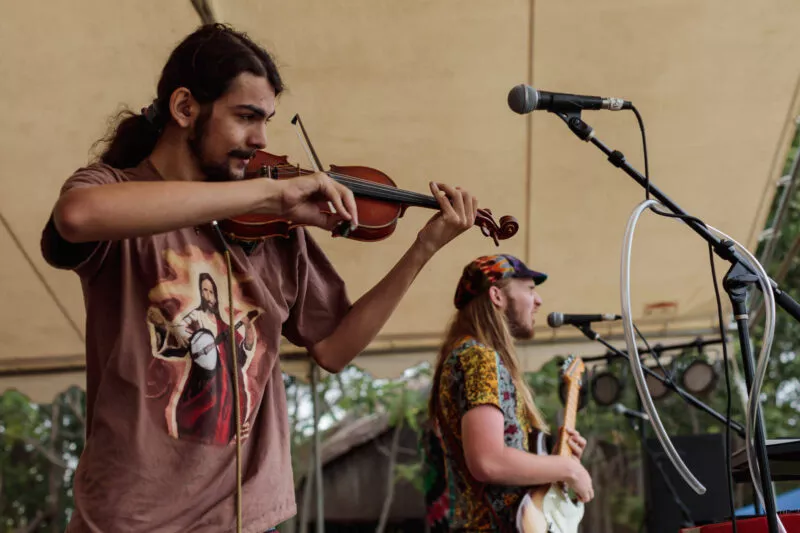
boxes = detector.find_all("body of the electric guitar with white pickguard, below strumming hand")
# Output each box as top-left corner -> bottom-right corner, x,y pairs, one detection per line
517,484 -> 584,533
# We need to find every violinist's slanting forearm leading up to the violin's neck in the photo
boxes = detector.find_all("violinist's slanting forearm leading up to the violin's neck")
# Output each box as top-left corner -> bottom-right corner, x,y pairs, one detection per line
311,237 -> 434,372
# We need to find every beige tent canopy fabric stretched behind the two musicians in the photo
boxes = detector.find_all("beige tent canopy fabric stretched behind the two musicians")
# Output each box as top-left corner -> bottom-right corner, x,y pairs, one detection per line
0,0 -> 800,397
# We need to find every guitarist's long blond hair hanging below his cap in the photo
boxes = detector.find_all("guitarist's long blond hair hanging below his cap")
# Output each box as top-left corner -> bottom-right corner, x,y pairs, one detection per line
428,280 -> 549,432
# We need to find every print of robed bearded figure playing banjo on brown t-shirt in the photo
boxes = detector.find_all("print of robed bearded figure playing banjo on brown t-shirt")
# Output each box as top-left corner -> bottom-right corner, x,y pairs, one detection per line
147,246 -> 264,445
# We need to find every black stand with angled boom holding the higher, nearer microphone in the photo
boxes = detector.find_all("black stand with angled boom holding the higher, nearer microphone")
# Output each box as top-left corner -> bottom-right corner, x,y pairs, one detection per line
553,110 -> 780,533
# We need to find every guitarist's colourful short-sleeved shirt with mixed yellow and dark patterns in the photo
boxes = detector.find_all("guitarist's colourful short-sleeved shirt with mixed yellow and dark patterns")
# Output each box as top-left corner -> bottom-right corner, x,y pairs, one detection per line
428,338 -> 541,531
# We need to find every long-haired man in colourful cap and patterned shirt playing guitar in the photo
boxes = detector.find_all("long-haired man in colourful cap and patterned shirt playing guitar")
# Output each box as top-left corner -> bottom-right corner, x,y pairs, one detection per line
429,255 -> 594,531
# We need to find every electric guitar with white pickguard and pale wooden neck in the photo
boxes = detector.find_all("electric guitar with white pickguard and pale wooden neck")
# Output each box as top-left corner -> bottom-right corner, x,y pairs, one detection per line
517,356 -> 584,533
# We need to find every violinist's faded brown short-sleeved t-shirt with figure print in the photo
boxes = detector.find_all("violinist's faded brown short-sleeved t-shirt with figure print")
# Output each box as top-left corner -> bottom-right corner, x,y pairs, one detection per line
42,160 -> 350,533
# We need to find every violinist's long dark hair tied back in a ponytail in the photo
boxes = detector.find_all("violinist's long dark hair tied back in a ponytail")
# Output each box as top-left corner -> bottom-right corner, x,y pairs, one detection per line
100,24 -> 284,168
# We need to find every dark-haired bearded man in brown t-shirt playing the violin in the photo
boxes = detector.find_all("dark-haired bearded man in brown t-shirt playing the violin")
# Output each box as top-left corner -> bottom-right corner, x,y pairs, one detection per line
42,24 -> 477,533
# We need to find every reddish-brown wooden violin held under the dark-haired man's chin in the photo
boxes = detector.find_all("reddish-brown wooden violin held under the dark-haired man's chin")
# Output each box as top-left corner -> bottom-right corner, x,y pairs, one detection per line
219,115 -> 519,246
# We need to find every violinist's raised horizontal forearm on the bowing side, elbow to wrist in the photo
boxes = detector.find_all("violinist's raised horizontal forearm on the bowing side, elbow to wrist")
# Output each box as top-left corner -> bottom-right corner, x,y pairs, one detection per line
54,179 -> 273,242
